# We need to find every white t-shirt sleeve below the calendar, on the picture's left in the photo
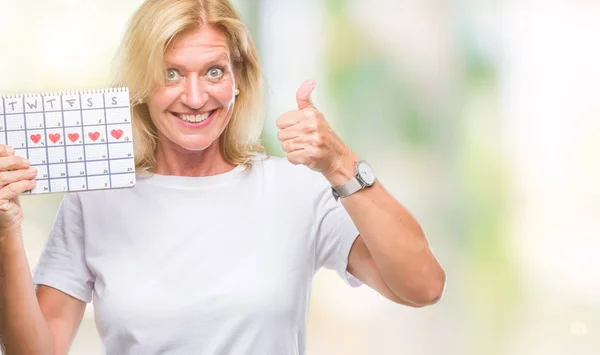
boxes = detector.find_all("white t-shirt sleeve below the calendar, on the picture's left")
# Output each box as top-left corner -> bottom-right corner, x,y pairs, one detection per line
33,193 -> 94,303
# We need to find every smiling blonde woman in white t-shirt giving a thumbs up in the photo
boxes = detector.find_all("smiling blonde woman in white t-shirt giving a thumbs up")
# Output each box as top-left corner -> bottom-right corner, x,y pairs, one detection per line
0,0 -> 445,354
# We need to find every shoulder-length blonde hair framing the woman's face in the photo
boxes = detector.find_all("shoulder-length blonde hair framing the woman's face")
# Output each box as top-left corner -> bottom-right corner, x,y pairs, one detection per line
113,0 -> 266,173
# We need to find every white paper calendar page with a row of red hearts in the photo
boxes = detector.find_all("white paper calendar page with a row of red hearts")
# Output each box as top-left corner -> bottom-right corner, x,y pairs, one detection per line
0,88 -> 136,194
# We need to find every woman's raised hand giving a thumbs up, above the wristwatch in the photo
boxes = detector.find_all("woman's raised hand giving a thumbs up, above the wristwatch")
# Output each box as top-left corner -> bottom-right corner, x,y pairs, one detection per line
276,80 -> 358,185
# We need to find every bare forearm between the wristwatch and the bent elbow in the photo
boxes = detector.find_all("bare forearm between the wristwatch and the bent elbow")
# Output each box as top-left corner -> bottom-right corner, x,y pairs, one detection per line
343,181 -> 445,305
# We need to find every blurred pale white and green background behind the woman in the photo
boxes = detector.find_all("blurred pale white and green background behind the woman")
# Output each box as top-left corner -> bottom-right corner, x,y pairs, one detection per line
0,0 -> 600,355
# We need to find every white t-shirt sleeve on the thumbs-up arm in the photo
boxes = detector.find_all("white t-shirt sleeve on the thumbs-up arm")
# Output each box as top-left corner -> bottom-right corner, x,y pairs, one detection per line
315,174 -> 362,287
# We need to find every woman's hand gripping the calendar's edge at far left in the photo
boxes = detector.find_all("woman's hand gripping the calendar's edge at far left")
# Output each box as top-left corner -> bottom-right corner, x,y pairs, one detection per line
0,144 -> 37,237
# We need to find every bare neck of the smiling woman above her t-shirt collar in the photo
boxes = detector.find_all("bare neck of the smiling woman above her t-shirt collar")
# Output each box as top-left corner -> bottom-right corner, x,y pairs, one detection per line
152,139 -> 235,176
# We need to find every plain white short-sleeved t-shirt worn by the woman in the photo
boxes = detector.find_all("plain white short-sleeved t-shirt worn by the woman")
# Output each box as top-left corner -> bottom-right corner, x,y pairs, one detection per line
33,157 -> 360,355
